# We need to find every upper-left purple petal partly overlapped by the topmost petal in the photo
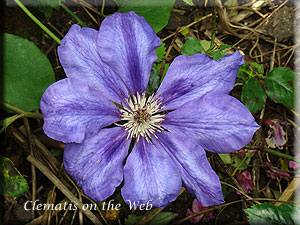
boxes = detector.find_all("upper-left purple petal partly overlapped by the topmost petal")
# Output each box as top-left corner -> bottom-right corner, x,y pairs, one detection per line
57,25 -> 127,101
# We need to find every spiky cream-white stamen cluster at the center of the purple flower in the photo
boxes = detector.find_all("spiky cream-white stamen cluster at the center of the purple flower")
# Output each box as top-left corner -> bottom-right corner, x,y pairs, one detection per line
119,93 -> 165,143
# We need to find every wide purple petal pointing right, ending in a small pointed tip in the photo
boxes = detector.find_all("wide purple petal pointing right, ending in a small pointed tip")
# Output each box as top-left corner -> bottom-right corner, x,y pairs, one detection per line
163,92 -> 259,153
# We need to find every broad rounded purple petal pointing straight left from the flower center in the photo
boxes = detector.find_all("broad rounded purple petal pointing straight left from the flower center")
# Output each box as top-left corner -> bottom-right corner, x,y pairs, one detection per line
40,78 -> 119,143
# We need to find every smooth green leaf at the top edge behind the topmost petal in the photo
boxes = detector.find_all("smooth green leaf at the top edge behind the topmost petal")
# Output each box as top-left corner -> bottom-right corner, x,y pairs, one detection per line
115,0 -> 175,33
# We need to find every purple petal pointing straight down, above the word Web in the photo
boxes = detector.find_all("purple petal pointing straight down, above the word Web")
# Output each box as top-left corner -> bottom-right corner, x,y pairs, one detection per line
122,139 -> 182,208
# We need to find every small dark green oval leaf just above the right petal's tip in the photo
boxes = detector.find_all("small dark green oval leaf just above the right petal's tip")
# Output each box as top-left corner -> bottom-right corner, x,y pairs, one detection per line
242,78 -> 267,113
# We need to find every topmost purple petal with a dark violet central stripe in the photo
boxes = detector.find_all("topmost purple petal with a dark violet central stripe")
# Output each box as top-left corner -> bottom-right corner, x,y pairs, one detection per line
98,12 -> 161,93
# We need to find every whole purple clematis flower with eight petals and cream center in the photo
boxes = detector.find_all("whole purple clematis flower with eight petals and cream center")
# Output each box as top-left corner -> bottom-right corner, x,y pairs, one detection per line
41,12 -> 258,207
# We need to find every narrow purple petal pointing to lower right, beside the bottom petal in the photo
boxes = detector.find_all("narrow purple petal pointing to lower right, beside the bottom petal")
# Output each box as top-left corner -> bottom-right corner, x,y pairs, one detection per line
157,132 -> 223,206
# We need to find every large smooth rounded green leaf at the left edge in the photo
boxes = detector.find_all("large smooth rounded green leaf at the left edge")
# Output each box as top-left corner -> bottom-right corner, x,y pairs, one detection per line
1,34 -> 55,111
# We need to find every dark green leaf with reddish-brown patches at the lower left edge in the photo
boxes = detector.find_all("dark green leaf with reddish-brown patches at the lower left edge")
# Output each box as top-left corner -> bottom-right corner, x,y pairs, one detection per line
0,155 -> 29,197
